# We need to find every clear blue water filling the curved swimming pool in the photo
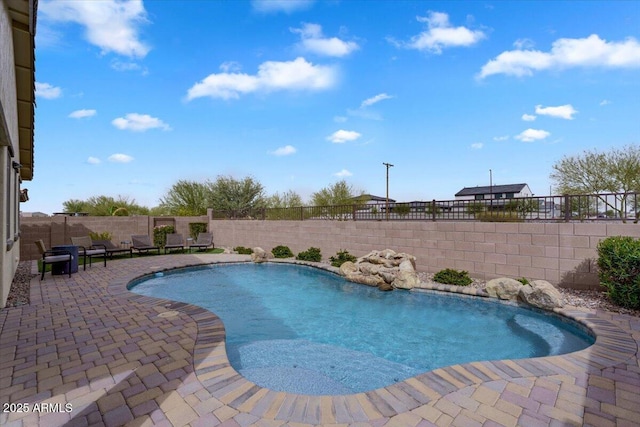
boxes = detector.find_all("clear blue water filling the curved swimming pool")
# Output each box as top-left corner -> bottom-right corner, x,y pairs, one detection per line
131,263 -> 594,394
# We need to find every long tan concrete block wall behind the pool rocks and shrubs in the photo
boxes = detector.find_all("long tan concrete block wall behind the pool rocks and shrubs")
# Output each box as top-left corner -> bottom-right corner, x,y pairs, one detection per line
209,220 -> 640,289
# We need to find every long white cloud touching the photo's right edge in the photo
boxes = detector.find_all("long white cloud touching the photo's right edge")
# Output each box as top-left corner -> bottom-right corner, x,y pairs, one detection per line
478,34 -> 640,79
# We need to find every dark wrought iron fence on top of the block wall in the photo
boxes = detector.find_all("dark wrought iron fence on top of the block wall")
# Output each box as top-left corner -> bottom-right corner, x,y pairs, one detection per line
211,193 -> 640,223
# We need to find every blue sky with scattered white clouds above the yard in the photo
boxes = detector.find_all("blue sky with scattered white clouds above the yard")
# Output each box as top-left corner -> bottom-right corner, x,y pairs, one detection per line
27,0 -> 640,213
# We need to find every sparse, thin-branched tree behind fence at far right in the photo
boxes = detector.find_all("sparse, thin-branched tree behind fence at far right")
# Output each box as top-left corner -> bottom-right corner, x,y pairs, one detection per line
550,145 -> 640,219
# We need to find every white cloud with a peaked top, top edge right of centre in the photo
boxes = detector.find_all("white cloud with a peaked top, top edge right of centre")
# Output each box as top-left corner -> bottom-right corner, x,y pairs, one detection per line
396,11 -> 485,54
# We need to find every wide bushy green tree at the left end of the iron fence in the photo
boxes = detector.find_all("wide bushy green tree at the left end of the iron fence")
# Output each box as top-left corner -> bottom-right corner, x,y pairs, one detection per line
207,176 -> 266,218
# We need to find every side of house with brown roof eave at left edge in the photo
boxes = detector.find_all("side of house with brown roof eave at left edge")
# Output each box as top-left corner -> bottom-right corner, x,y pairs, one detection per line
0,0 -> 37,307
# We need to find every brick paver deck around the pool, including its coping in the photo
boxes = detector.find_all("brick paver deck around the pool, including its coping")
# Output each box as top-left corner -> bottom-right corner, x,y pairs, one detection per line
0,254 -> 640,427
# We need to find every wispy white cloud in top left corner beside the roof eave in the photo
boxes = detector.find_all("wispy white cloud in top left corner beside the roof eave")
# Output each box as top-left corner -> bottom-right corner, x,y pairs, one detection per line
38,0 -> 150,58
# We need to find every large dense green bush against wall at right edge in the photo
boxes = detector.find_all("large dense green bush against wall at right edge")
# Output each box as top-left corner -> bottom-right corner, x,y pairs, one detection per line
598,236 -> 640,310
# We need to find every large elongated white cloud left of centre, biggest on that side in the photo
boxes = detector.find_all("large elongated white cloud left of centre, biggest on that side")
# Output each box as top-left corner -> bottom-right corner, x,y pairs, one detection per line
187,57 -> 337,101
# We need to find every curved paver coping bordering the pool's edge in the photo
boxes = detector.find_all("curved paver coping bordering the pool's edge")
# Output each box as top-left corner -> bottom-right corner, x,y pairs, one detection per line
108,260 -> 638,425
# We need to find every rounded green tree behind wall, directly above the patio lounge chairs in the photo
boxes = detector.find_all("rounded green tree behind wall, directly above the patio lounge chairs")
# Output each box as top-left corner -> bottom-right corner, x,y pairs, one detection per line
160,180 -> 212,216
